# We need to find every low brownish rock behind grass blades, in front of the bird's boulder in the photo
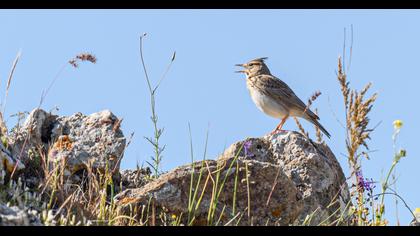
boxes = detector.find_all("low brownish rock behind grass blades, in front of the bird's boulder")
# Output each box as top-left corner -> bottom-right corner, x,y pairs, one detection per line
115,158 -> 303,225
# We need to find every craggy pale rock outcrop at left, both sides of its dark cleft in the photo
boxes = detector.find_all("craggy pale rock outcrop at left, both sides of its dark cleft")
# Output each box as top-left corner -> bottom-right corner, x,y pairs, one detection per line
10,109 -> 126,182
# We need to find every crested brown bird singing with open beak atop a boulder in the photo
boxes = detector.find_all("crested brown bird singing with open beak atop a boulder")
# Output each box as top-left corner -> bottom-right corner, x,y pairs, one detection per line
235,57 -> 331,138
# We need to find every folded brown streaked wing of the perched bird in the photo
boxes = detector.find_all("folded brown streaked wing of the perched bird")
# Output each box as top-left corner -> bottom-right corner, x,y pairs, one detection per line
254,75 -> 318,119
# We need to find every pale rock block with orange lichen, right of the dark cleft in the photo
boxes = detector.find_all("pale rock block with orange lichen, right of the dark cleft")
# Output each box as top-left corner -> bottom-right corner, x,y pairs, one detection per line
48,110 -> 126,178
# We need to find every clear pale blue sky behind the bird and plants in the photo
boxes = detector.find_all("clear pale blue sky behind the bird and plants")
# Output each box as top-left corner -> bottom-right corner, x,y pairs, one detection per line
0,10 -> 420,225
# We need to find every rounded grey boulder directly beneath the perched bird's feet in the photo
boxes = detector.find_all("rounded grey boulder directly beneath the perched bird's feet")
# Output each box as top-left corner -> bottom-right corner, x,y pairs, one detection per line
226,131 -> 350,225
